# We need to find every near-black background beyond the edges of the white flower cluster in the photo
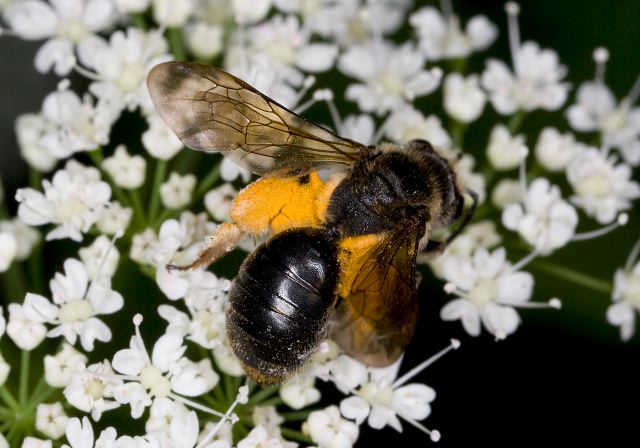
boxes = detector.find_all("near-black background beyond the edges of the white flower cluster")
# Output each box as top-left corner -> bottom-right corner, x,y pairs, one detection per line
0,0 -> 640,447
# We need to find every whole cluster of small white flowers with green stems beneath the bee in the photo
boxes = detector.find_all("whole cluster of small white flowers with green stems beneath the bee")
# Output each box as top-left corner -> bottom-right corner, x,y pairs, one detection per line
0,0 -> 640,448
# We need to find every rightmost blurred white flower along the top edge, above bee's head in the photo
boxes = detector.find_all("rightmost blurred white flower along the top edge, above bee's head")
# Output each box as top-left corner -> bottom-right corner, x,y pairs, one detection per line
409,6 -> 498,61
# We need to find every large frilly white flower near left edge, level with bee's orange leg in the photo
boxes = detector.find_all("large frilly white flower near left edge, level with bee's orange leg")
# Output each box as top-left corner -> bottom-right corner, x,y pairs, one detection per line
16,160 -> 111,241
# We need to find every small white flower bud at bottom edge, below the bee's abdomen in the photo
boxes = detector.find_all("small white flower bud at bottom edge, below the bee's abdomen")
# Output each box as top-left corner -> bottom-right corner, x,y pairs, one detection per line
303,406 -> 360,448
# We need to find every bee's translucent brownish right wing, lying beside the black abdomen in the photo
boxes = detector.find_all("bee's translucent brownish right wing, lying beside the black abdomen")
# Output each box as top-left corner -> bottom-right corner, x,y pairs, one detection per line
330,220 -> 425,367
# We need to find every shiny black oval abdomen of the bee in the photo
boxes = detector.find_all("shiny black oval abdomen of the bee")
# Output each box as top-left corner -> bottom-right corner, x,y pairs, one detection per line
227,229 -> 339,383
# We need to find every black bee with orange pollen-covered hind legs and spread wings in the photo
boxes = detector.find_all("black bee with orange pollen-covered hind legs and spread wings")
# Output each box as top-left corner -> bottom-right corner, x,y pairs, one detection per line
147,62 -> 477,384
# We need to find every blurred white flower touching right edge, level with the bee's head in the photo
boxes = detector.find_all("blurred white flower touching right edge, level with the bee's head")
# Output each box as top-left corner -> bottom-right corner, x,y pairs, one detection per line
567,148 -> 640,224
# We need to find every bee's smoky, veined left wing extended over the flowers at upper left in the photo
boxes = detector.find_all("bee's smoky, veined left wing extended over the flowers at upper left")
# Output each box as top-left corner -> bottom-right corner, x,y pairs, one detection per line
147,62 -> 364,175
